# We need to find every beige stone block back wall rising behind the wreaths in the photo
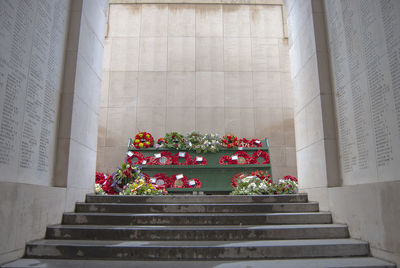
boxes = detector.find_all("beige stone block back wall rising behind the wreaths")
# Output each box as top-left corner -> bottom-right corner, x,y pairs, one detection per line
97,4 -> 296,177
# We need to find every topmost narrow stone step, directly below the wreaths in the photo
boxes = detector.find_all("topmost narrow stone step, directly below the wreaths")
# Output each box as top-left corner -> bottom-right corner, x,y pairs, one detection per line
86,193 -> 308,204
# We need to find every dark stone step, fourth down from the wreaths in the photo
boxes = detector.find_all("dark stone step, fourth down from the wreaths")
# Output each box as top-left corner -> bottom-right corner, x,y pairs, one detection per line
46,224 -> 349,241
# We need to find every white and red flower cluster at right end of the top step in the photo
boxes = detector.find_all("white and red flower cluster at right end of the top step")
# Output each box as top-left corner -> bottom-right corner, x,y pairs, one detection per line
231,176 -> 298,195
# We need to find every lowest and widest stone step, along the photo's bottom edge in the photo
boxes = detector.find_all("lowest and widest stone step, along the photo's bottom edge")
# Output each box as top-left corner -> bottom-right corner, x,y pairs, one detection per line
1,257 -> 396,268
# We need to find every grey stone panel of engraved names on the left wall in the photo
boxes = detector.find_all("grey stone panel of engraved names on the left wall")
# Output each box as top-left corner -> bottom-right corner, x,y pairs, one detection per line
0,0 -> 69,185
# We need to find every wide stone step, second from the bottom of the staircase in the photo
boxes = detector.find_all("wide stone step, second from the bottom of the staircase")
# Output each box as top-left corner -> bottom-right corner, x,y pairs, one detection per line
26,239 -> 369,260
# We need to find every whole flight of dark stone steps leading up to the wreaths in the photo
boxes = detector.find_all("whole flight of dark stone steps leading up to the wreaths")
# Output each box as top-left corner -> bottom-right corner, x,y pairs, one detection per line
3,194 -> 395,268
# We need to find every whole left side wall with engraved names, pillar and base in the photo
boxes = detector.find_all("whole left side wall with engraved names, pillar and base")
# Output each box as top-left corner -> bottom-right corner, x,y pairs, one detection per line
0,0 -> 108,264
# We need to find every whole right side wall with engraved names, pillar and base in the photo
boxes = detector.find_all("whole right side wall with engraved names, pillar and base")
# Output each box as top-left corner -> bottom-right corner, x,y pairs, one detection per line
285,0 -> 400,265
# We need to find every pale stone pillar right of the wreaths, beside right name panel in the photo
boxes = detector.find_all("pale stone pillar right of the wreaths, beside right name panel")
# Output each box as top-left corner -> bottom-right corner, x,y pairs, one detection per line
285,0 -> 340,209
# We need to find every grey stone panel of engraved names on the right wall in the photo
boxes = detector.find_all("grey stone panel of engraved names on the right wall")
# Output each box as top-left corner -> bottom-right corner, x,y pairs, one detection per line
325,0 -> 400,185
